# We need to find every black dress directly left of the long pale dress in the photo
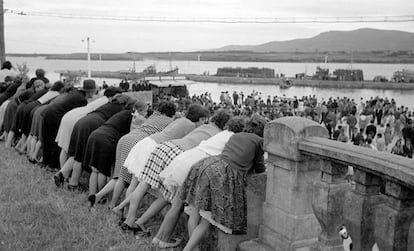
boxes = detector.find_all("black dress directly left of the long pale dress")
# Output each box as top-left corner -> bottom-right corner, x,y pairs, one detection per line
41,89 -> 88,169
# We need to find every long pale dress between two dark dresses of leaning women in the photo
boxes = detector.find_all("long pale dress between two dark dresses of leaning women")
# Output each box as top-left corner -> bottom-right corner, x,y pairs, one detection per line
55,96 -> 109,152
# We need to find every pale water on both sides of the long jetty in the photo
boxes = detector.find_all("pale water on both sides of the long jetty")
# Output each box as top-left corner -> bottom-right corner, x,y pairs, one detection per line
8,57 -> 414,108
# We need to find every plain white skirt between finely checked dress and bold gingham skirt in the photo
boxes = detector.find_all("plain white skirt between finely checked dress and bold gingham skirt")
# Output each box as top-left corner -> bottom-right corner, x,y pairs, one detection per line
124,137 -> 158,176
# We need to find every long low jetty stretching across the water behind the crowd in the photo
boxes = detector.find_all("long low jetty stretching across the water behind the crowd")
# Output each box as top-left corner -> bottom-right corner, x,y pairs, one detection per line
186,74 -> 414,90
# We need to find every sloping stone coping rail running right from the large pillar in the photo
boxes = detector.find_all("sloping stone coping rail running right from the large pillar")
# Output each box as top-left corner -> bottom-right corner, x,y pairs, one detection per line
298,137 -> 414,187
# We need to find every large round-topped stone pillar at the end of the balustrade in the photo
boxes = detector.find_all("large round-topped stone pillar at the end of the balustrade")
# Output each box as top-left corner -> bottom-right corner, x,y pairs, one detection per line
241,117 -> 328,251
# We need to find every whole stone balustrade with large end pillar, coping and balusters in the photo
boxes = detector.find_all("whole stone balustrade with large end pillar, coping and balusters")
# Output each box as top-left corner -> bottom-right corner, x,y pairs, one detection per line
239,117 -> 414,251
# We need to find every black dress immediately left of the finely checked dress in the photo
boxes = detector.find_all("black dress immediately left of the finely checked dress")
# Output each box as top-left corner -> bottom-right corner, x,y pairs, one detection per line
83,110 -> 132,177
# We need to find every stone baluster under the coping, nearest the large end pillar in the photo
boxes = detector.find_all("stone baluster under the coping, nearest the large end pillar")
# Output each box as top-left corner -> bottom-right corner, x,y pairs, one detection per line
313,160 -> 352,251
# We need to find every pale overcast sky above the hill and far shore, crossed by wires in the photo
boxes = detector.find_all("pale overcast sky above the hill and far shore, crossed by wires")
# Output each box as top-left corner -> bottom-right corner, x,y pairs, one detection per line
3,0 -> 414,53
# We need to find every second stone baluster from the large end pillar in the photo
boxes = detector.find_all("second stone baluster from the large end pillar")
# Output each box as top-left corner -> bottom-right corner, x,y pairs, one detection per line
343,167 -> 382,250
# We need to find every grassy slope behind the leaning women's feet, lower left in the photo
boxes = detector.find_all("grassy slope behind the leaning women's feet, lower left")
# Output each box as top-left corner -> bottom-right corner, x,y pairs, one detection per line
0,144 -> 185,251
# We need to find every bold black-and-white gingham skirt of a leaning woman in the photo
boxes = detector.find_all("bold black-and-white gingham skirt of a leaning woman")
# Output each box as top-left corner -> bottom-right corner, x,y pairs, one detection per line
137,141 -> 183,194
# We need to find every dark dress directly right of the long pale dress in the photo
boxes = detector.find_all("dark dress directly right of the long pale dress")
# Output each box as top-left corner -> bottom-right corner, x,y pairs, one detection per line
68,102 -> 125,170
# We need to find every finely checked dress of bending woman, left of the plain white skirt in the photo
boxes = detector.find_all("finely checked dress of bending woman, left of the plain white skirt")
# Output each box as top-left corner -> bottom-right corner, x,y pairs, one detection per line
113,112 -> 173,183
